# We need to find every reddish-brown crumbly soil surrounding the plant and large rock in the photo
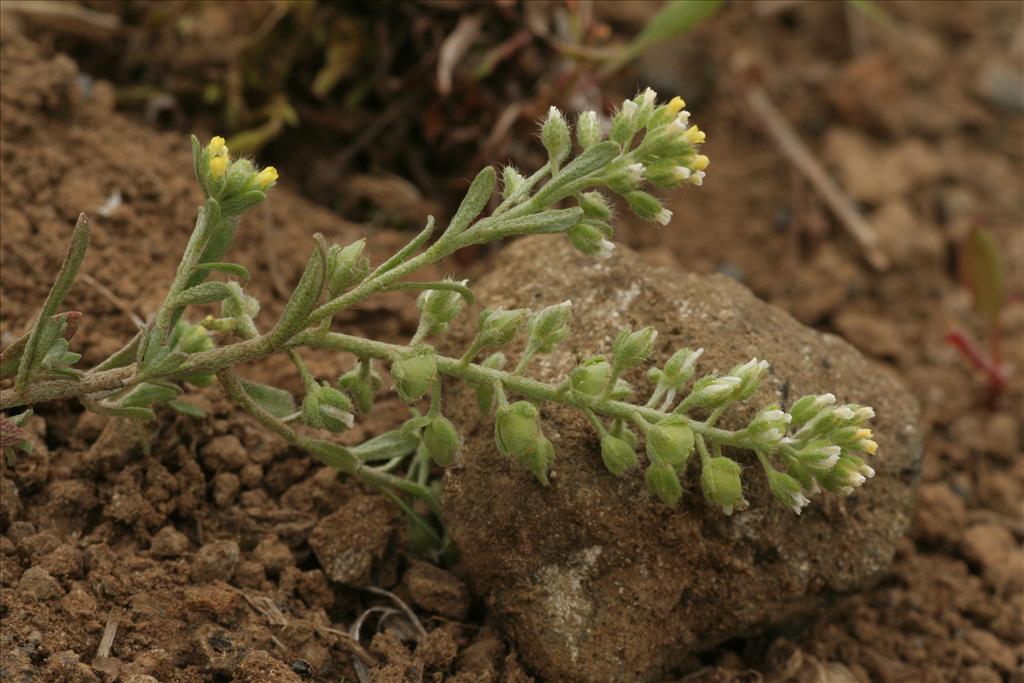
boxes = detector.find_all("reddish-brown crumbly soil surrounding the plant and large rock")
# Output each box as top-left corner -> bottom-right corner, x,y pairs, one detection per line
0,2 -> 1024,682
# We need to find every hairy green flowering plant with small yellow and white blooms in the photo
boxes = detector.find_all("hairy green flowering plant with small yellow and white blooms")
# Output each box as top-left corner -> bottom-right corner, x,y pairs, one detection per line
0,89 -> 877,546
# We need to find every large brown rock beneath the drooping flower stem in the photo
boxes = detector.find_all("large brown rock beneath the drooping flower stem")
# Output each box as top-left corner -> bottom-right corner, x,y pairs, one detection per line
443,237 -> 921,682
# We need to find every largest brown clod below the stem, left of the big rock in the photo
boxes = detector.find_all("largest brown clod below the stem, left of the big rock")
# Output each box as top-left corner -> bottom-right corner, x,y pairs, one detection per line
309,496 -> 398,586
